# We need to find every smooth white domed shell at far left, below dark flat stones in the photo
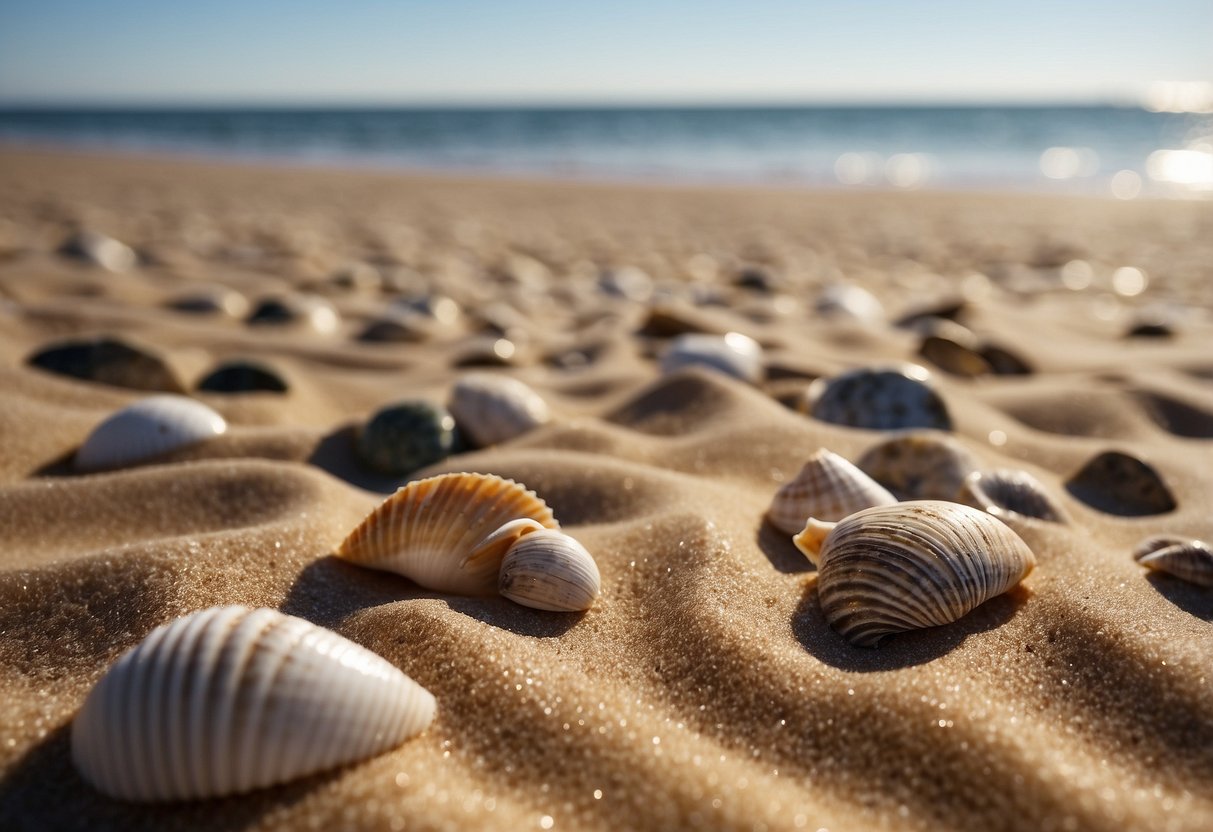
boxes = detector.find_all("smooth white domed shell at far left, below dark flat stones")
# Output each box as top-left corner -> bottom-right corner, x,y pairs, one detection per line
75,395 -> 227,471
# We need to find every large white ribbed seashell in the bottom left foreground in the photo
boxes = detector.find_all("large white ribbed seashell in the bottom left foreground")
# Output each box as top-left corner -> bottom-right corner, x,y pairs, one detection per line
72,606 -> 435,802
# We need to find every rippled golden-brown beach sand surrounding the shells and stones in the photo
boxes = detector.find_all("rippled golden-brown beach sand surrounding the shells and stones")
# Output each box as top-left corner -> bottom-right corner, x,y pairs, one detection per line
0,149 -> 1213,831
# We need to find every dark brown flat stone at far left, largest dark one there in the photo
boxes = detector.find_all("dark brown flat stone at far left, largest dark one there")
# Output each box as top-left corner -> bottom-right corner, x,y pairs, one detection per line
27,336 -> 186,393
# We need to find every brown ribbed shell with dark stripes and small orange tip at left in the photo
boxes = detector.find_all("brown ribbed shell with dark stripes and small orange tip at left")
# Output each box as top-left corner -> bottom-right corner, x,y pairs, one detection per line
793,500 -> 1036,646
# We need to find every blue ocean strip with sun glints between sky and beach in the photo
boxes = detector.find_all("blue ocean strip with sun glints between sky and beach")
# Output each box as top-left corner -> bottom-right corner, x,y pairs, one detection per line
0,106 -> 1213,199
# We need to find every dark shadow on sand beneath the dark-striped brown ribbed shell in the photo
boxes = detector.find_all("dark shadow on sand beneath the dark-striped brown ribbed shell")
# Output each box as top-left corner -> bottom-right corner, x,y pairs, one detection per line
792,581 -> 1031,673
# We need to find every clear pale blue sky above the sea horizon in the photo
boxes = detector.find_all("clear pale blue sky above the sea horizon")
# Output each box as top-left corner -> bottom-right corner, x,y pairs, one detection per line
0,0 -> 1213,104
